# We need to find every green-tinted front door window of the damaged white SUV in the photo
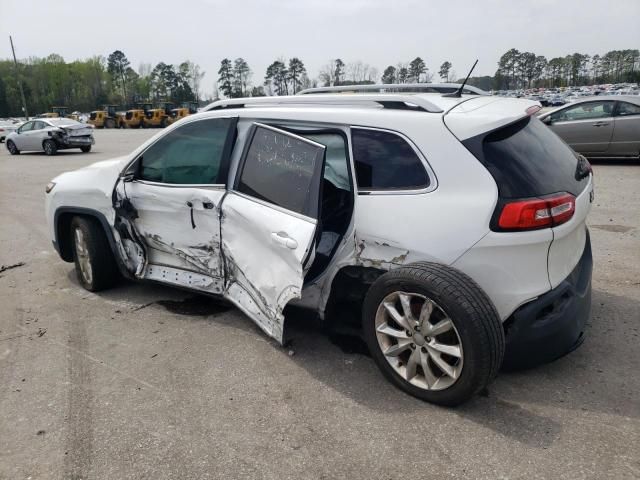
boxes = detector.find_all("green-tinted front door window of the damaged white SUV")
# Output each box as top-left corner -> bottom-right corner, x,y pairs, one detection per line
140,118 -> 236,185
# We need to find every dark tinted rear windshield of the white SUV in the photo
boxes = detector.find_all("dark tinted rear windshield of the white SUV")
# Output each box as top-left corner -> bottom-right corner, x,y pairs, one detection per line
462,117 -> 588,198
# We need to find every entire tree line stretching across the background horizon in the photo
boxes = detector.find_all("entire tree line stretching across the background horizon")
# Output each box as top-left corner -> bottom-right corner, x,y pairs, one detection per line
0,48 -> 640,117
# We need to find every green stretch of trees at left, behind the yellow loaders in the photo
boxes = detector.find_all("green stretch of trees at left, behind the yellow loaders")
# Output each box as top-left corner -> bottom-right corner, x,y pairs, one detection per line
0,50 -> 205,117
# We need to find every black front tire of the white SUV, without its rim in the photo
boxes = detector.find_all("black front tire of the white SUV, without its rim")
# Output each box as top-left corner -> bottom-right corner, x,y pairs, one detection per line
71,217 -> 120,292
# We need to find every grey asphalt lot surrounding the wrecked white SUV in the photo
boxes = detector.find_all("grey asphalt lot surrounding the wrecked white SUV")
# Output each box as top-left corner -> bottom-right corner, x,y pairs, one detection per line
0,130 -> 640,479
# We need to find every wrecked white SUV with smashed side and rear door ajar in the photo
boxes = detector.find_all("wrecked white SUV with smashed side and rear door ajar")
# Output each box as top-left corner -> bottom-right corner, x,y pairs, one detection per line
46,89 -> 593,405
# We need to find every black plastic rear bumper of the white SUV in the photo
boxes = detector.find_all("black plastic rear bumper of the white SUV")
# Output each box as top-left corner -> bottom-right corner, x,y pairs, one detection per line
502,231 -> 593,370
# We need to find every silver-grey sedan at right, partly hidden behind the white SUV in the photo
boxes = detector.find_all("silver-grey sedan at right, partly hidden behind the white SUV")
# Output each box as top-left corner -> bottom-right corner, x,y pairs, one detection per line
539,95 -> 640,158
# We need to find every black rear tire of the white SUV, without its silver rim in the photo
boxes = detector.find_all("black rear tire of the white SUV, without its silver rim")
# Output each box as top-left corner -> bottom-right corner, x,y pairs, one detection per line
362,262 -> 505,406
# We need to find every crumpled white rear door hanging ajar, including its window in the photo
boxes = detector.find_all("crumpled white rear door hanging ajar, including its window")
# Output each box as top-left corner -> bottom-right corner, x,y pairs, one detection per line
221,124 -> 325,342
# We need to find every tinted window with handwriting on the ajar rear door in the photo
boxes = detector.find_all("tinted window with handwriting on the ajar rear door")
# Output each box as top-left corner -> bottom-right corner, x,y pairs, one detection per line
236,125 -> 325,218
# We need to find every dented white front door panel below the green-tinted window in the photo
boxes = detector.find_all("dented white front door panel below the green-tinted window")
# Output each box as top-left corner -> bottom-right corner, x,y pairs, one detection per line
114,181 -> 224,293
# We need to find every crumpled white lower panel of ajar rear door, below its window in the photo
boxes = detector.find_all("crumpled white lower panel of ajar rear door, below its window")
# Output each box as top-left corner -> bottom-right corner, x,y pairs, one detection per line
221,192 -> 317,343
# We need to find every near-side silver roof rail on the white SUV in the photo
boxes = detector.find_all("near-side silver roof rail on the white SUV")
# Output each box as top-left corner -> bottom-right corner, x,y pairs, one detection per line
200,94 -> 443,113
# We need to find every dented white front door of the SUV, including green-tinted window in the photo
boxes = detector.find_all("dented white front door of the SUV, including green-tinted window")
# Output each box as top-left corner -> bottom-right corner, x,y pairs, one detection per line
115,117 -> 237,294
